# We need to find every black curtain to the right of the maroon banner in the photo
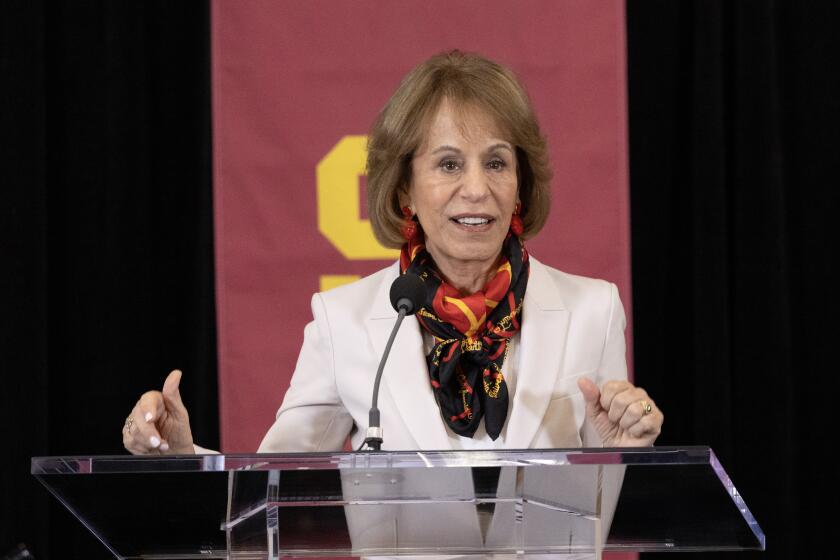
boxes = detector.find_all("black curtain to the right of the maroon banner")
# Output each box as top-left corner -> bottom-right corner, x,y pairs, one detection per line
627,0 -> 840,558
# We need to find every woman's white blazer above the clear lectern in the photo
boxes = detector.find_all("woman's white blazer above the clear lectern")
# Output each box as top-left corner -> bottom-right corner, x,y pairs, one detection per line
259,257 -> 627,453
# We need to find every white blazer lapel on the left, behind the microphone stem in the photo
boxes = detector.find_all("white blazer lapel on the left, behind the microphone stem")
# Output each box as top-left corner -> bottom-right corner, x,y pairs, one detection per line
365,265 -> 451,450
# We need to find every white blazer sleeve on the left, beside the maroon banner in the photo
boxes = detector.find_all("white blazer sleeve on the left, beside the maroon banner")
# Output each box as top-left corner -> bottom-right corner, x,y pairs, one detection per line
259,294 -> 353,453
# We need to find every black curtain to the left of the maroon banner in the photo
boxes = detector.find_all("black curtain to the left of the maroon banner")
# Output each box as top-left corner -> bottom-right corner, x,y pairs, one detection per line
0,1 -> 219,560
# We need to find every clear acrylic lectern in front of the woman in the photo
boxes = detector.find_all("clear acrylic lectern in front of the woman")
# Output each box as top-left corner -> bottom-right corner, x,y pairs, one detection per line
32,447 -> 764,558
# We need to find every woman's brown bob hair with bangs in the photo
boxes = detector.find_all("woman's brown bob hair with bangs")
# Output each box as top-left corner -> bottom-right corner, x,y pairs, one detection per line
367,50 -> 551,248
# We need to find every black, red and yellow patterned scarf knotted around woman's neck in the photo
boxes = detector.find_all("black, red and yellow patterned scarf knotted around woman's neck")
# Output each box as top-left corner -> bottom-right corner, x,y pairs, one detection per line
400,233 -> 530,440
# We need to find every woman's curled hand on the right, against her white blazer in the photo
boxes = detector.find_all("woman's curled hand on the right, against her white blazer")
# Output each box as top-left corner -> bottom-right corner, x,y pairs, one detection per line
578,377 -> 665,447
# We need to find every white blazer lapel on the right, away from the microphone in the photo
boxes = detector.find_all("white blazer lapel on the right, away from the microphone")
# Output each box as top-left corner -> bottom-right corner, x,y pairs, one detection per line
505,258 -> 569,449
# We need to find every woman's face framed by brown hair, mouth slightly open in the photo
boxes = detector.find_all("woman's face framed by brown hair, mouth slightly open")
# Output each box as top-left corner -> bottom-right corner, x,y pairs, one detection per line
405,100 -> 518,274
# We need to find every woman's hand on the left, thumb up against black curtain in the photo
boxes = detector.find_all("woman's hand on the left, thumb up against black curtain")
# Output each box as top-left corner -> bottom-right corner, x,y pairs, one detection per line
123,369 -> 195,455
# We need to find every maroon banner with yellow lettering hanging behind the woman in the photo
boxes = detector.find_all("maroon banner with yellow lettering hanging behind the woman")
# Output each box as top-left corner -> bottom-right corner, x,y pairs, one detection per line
212,0 -> 630,452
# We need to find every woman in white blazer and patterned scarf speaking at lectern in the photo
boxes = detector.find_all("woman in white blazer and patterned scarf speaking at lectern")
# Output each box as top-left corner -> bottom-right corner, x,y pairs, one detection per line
123,51 -> 663,454
